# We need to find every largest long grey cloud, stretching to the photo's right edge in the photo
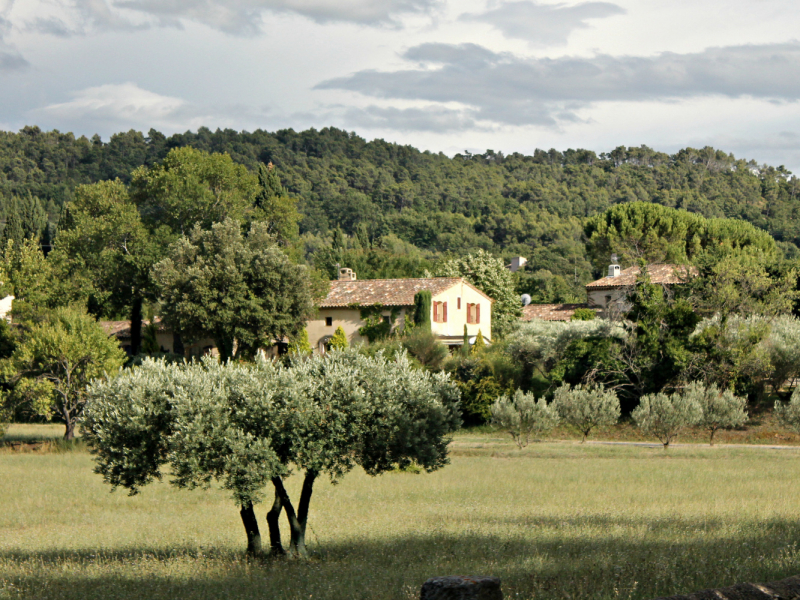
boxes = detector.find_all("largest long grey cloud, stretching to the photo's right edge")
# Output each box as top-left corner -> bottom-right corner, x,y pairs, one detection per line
317,43 -> 800,126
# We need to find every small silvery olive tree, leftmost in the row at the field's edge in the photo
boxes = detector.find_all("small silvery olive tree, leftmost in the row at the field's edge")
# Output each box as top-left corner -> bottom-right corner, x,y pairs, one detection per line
491,390 -> 559,448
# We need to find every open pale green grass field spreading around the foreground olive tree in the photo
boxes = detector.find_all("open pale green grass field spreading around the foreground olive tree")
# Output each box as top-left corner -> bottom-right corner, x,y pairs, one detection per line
0,430 -> 800,600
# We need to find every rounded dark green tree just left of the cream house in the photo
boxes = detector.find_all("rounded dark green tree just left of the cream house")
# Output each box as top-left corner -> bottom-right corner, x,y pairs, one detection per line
153,219 -> 313,358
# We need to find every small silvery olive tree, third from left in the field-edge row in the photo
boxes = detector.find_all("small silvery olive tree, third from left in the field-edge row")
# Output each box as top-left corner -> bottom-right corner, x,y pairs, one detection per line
631,393 -> 703,448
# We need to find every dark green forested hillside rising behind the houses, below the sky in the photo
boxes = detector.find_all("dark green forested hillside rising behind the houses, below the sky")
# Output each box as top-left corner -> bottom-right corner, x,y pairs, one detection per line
0,127 -> 800,300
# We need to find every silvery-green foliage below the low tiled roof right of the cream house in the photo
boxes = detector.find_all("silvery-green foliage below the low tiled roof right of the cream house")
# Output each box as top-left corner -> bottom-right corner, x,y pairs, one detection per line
508,319 -> 625,364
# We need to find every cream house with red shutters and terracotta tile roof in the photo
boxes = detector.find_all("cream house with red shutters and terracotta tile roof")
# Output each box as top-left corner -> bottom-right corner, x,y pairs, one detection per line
306,269 -> 494,353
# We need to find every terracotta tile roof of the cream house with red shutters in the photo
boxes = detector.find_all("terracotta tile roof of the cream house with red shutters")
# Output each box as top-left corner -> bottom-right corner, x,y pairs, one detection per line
320,277 -> 468,308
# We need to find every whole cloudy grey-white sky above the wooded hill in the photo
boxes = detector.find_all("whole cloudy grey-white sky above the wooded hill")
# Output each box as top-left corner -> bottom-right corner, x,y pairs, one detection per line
0,0 -> 800,173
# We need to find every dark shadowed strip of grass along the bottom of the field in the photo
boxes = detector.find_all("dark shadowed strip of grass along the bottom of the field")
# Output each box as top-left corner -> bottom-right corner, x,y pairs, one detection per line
0,516 -> 800,600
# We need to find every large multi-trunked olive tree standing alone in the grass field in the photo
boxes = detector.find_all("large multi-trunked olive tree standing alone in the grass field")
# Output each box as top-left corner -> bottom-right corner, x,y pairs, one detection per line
83,351 -> 460,556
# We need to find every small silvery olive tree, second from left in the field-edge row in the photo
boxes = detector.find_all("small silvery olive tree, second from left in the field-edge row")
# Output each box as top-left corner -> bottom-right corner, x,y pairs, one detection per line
553,384 -> 621,441
